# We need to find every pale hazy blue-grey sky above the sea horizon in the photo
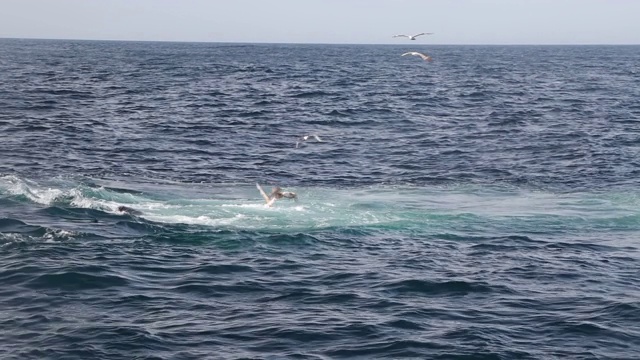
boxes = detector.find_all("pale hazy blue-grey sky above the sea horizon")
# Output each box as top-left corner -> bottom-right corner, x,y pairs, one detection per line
0,0 -> 640,44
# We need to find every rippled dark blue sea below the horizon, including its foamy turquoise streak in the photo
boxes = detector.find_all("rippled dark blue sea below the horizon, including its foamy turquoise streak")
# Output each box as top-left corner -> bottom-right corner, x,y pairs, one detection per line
0,39 -> 640,359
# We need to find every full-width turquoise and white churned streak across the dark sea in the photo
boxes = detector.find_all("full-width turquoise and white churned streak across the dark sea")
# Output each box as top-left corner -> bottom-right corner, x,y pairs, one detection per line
0,175 -> 640,235
